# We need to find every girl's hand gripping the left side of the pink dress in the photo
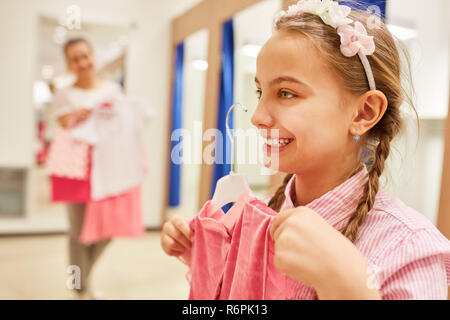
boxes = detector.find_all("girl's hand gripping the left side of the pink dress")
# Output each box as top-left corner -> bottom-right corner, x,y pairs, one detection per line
161,215 -> 193,256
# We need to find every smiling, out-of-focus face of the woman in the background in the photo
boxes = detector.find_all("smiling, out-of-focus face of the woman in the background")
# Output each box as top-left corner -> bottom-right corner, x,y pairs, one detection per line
66,42 -> 95,79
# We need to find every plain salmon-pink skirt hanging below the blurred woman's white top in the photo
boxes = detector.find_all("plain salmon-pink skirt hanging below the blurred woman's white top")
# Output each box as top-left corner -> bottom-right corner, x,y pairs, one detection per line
79,186 -> 145,244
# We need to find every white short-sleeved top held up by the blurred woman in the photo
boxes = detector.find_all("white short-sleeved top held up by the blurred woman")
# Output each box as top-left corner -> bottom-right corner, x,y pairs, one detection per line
73,93 -> 152,200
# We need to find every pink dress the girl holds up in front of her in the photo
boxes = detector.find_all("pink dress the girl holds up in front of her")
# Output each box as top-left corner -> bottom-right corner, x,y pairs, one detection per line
183,190 -> 298,300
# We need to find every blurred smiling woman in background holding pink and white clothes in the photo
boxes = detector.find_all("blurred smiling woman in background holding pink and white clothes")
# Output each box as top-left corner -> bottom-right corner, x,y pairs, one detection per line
49,38 -> 148,299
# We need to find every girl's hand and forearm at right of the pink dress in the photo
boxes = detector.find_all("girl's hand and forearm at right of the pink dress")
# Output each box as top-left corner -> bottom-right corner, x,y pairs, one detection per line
270,207 -> 379,299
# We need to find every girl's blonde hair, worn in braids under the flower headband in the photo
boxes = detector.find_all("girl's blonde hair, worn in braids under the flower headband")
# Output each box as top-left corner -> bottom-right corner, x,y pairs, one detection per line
269,10 -> 417,242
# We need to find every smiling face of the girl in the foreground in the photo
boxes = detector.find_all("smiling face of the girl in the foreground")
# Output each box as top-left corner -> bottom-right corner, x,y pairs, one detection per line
252,31 -> 356,174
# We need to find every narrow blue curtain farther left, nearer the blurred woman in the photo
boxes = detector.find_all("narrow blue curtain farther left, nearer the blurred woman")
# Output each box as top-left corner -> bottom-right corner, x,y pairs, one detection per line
169,43 -> 184,207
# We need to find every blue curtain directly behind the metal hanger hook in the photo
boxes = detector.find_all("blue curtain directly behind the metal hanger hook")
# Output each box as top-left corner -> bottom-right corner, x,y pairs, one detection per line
211,19 -> 234,212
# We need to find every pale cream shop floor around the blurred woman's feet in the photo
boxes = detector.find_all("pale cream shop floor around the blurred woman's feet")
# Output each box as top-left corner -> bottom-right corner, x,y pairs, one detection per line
0,231 -> 189,299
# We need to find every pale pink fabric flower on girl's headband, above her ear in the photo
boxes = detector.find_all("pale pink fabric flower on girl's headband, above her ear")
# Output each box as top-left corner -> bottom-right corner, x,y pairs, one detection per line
337,21 -> 375,57
